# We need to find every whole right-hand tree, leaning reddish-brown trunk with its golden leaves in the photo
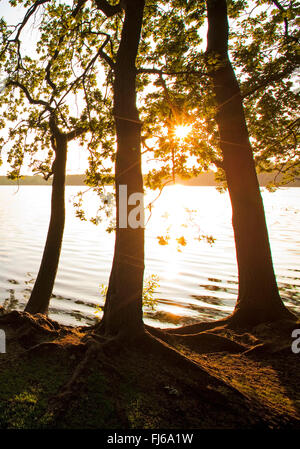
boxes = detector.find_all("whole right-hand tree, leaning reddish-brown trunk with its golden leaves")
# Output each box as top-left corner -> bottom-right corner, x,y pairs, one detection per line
135,0 -> 297,325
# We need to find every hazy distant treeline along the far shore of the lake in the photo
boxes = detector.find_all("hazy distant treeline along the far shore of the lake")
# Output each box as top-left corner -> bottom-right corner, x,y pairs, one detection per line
0,172 -> 300,187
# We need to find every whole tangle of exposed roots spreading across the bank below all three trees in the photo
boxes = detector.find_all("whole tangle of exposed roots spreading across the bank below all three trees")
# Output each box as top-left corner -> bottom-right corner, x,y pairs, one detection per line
0,312 -> 295,427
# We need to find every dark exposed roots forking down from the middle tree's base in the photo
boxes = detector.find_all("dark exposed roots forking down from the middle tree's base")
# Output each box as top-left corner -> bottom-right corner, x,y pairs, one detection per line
44,324 -> 251,420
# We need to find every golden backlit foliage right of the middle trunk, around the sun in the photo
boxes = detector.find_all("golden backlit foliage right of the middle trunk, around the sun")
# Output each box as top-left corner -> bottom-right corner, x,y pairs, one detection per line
140,1 -> 299,188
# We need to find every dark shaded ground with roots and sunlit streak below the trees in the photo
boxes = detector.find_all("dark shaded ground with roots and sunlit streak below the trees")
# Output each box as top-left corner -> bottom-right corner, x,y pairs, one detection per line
0,310 -> 300,429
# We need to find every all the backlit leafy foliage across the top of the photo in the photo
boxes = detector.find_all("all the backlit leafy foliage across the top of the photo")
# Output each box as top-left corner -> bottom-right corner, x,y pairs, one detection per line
0,0 -> 299,200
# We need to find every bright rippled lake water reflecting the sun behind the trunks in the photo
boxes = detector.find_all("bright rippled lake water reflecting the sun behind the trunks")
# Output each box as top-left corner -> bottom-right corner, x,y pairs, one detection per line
0,186 -> 300,327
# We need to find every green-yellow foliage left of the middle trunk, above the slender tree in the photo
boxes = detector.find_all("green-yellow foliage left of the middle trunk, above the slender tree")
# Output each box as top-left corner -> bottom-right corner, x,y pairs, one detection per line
0,2 -> 114,188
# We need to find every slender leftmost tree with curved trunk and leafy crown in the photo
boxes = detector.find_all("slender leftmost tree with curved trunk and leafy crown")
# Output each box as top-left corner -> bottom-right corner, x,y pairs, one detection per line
2,1 -> 109,314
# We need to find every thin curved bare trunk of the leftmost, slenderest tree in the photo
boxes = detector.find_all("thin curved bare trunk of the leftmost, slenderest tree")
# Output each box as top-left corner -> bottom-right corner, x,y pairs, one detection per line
25,134 -> 67,314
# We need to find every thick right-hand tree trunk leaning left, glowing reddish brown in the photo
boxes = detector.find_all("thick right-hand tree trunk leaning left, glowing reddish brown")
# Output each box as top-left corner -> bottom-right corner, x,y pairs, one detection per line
206,0 -> 292,324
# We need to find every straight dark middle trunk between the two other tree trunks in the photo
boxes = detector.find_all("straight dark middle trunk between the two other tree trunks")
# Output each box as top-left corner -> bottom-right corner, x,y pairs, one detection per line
101,0 -> 144,336
